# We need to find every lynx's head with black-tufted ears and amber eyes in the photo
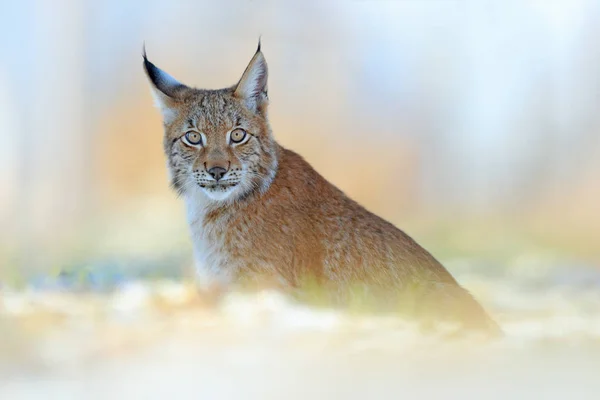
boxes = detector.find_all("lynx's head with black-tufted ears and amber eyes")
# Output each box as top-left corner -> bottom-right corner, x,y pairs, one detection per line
144,43 -> 277,202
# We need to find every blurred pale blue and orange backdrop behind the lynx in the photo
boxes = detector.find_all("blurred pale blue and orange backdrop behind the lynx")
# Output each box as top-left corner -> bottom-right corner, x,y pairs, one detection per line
0,0 -> 600,396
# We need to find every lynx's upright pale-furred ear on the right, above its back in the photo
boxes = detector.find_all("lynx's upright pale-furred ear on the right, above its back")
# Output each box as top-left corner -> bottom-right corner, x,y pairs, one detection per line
234,40 -> 268,112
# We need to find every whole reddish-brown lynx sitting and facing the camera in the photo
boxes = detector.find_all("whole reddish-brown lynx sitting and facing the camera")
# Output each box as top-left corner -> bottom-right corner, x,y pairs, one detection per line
144,44 -> 499,333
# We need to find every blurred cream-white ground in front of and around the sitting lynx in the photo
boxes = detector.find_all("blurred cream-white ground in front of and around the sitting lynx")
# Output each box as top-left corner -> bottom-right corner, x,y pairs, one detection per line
0,260 -> 600,400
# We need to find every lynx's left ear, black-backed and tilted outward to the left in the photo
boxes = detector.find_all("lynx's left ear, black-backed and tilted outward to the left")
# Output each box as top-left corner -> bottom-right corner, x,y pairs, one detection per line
143,48 -> 188,123
